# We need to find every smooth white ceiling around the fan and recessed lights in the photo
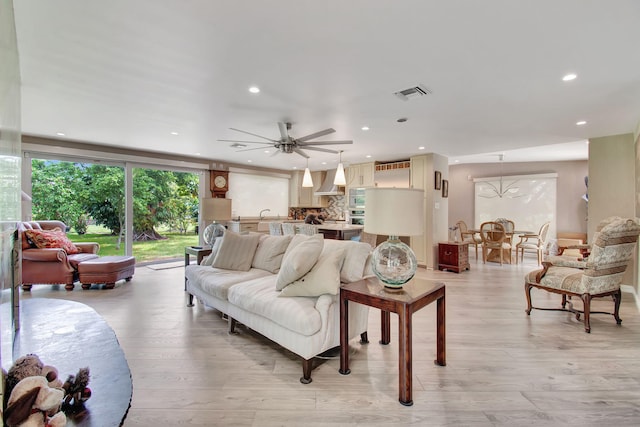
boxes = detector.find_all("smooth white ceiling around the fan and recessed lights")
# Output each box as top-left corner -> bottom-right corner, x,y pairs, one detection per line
14,0 -> 640,169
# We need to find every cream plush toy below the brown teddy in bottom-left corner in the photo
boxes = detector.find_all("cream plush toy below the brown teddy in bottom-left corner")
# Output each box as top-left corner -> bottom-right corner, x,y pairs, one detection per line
4,375 -> 67,427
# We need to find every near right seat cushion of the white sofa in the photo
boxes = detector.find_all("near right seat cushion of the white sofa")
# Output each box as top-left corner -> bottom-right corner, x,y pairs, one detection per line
229,275 -> 322,336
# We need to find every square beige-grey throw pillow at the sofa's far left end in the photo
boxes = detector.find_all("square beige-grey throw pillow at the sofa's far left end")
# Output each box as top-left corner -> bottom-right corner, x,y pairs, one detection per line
212,230 -> 260,271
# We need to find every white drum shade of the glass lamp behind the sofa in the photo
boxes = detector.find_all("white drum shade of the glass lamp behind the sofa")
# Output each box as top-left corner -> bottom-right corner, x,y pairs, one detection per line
364,188 -> 424,236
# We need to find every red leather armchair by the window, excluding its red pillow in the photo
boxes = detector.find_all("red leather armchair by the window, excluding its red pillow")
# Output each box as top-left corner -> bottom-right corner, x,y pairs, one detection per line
19,221 -> 100,291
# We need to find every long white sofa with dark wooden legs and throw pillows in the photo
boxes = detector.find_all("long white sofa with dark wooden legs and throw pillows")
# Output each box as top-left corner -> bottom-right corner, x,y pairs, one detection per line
185,231 -> 371,384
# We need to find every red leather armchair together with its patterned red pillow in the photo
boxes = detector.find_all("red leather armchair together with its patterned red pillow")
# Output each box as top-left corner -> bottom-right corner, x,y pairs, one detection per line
19,221 -> 100,291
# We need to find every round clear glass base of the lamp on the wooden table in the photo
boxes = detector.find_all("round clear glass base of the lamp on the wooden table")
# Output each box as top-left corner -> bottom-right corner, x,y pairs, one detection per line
371,236 -> 418,289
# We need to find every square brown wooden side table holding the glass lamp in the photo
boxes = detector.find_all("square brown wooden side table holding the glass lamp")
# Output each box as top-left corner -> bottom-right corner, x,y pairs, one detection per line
339,277 -> 446,406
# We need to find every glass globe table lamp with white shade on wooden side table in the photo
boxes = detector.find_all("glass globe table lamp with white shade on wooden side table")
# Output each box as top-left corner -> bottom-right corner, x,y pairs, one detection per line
364,188 -> 424,288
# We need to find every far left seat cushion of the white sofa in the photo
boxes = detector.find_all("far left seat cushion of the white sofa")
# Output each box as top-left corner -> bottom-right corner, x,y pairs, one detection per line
185,264 -> 275,301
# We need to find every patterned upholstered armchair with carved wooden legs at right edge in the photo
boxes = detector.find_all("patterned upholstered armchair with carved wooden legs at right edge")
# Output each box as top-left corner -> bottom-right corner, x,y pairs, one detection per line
524,217 -> 640,332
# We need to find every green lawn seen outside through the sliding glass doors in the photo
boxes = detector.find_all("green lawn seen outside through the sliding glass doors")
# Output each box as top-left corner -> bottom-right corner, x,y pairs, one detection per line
67,226 -> 198,263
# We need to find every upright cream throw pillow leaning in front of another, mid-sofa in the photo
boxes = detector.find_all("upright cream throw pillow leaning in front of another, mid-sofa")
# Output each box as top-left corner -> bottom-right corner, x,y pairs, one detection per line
276,234 -> 324,291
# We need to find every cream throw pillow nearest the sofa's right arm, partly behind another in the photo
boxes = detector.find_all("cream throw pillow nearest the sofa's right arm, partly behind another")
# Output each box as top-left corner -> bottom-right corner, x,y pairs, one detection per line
278,249 -> 344,297
